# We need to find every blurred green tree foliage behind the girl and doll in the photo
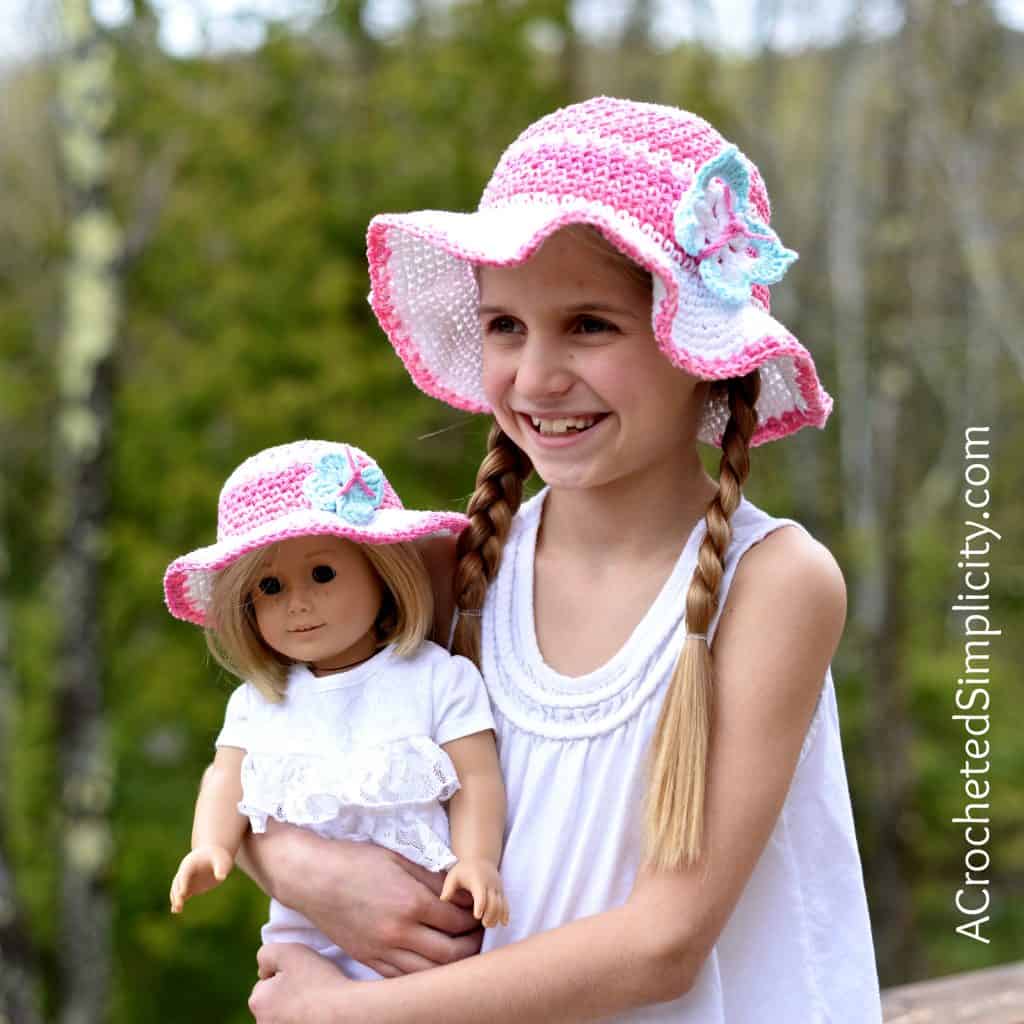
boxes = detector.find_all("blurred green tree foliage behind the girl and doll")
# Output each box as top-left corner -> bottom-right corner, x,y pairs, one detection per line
0,0 -> 1024,1024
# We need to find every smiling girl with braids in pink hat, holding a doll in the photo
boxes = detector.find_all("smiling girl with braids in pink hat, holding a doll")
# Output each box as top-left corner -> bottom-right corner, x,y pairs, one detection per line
249,97 -> 881,1024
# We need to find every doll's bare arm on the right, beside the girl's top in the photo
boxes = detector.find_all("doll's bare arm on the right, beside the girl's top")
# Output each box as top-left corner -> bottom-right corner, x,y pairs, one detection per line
441,729 -> 509,928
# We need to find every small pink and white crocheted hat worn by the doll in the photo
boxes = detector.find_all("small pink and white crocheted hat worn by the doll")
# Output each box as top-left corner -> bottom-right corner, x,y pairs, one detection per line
164,440 -> 469,626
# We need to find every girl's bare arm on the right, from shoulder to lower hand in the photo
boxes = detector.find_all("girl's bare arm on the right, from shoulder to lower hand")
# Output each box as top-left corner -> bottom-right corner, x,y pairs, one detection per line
250,528 -> 846,1024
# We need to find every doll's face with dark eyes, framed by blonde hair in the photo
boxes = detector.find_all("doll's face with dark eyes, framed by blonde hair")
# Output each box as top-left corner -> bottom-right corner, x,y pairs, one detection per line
252,537 -> 383,675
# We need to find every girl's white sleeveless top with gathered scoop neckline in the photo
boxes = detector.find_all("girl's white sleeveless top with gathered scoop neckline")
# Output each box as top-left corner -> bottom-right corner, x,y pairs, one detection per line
482,490 -> 882,1024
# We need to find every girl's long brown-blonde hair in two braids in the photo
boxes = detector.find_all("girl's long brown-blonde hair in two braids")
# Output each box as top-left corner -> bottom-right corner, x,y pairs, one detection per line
453,227 -> 761,869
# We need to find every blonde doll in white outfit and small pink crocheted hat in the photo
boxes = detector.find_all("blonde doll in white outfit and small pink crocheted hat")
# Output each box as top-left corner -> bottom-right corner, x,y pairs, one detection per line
164,441 -> 508,980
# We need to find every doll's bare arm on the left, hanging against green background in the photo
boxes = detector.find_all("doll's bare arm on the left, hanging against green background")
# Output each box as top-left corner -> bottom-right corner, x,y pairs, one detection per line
171,746 -> 249,913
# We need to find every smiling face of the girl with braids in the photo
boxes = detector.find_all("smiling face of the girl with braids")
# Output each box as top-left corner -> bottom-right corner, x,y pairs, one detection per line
478,231 -> 710,487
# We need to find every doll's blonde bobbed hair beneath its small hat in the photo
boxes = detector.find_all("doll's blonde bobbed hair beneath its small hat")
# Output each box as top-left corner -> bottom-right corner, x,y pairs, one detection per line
204,541 -> 434,702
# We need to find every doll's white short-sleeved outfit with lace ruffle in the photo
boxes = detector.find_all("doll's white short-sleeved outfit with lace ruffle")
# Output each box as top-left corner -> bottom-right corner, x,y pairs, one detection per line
216,643 -> 495,980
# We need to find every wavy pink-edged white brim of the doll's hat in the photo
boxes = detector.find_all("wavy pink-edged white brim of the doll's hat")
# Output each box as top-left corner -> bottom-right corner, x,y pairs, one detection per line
164,508 -> 469,626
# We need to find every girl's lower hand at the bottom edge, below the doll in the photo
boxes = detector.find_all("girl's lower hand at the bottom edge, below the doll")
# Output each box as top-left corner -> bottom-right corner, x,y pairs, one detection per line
249,943 -> 366,1024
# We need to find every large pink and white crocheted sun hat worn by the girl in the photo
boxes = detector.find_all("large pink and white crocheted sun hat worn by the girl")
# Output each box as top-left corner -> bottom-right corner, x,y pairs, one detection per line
368,96 -> 831,445
